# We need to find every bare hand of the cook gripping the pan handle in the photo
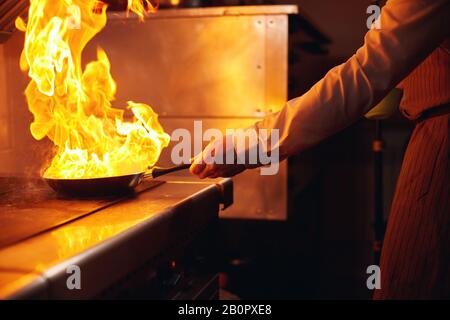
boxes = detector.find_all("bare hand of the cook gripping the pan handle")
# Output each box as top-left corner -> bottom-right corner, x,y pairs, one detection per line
189,136 -> 246,179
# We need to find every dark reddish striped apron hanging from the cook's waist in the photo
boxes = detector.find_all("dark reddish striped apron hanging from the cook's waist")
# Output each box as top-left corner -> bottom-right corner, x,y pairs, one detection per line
374,105 -> 450,299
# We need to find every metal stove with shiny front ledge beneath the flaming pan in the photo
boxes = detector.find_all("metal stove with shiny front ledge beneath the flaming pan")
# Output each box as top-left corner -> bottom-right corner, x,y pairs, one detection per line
0,176 -> 233,299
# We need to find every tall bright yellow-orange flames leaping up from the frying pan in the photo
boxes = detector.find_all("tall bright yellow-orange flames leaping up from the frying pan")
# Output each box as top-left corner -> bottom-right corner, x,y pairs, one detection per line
16,0 -> 170,179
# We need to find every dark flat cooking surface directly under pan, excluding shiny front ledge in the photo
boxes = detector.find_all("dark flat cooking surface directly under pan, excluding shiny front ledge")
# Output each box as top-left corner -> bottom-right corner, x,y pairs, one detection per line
0,177 -> 164,249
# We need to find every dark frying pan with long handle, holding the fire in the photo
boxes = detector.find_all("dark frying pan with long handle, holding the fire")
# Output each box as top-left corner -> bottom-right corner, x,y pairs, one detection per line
44,164 -> 190,197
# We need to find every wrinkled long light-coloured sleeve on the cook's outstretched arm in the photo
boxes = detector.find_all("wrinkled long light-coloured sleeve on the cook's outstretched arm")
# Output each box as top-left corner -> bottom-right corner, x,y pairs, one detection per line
255,0 -> 450,158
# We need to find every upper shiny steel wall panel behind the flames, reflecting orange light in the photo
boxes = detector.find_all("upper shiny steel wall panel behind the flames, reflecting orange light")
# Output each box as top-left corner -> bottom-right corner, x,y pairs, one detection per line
85,15 -> 287,117
